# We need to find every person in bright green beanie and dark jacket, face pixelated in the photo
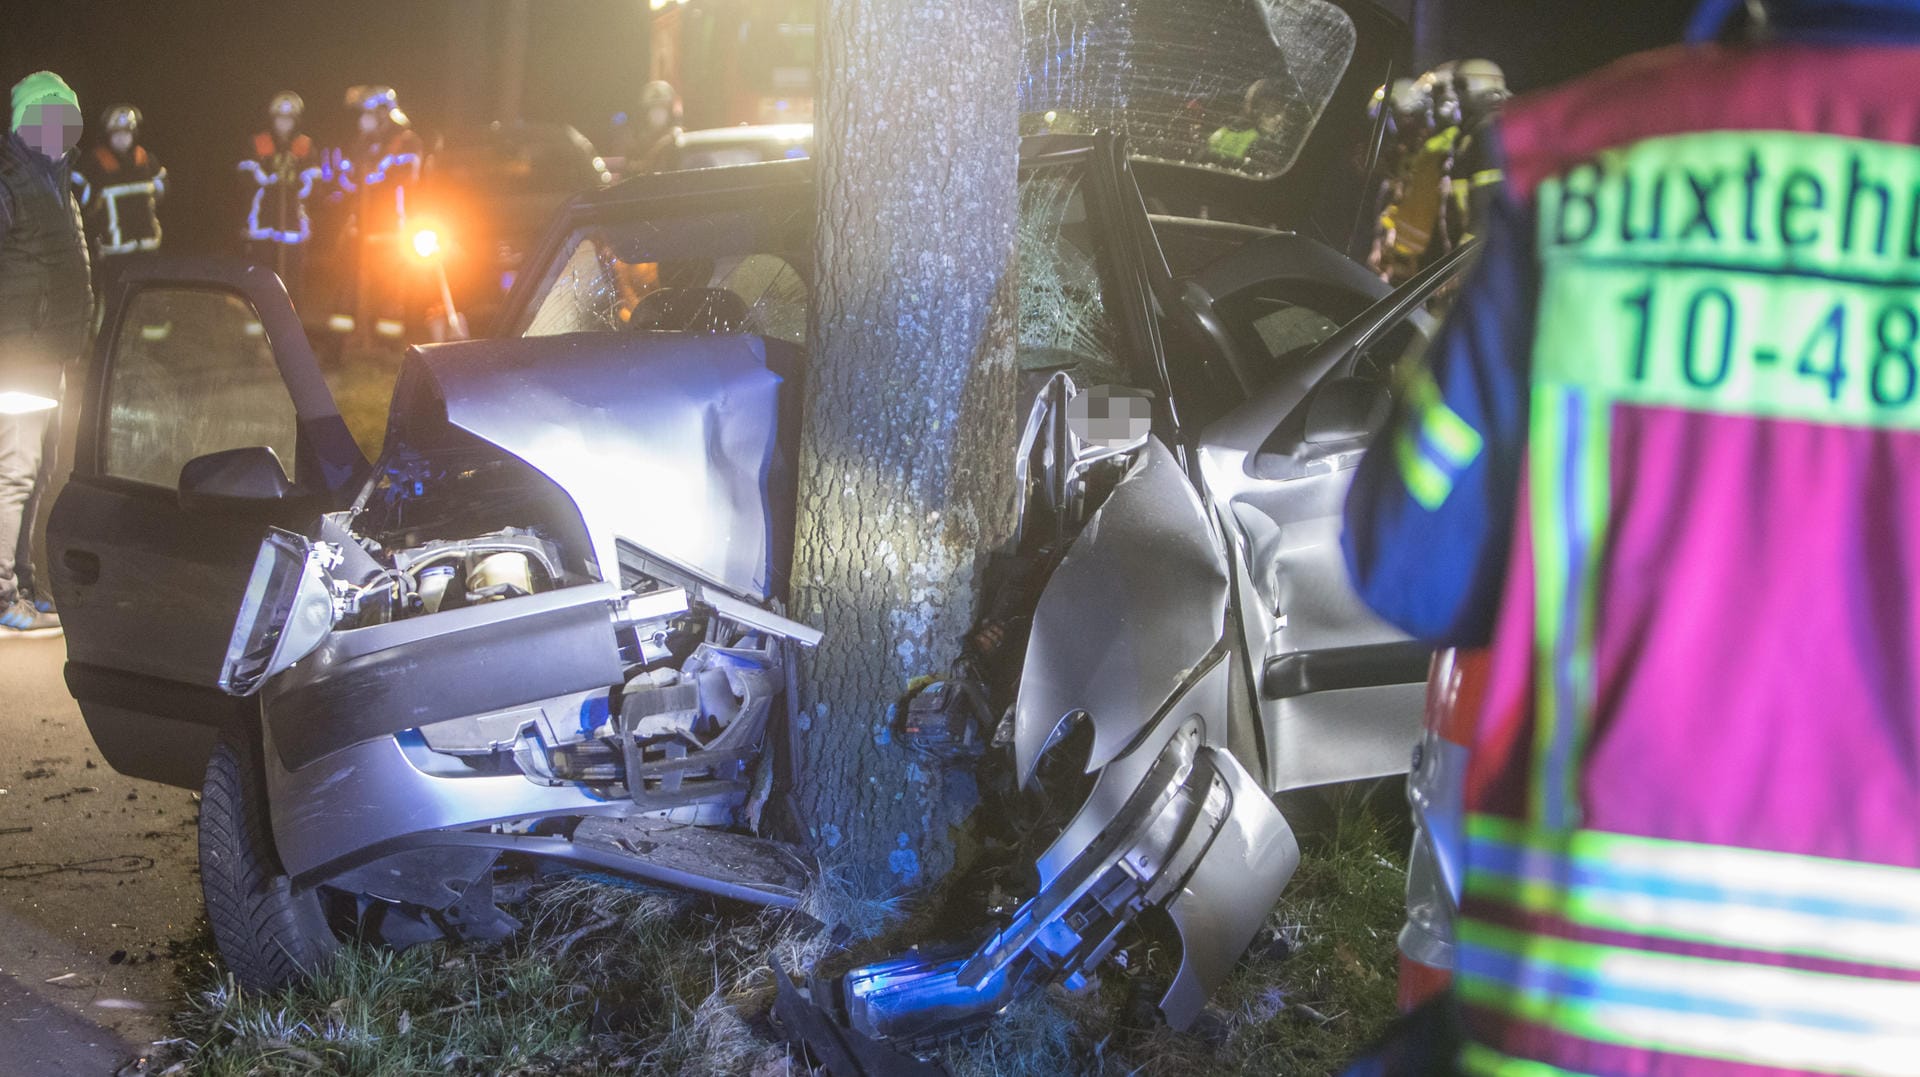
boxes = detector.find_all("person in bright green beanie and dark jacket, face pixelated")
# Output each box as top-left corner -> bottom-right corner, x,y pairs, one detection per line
0,71 -> 94,639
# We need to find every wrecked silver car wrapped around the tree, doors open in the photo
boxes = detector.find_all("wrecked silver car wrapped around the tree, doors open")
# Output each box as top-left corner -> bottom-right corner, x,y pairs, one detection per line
52,82 -> 1452,1041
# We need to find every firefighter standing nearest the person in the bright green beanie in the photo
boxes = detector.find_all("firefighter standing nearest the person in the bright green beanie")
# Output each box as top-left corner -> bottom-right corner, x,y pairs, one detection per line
73,106 -> 167,280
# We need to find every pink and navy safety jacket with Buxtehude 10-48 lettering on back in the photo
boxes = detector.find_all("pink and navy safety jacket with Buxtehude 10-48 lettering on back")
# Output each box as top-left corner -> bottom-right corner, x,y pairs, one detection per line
1346,42 -> 1920,1077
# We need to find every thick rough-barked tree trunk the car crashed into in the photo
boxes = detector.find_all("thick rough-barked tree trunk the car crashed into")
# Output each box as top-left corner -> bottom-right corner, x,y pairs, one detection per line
793,0 -> 1020,893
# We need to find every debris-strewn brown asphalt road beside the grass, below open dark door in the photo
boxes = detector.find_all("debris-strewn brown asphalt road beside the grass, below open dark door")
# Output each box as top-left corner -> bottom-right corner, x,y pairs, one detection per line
0,639 -> 202,1075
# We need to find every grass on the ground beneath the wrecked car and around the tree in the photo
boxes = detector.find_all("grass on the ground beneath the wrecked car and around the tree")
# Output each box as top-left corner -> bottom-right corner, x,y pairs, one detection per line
131,787 -> 1405,1077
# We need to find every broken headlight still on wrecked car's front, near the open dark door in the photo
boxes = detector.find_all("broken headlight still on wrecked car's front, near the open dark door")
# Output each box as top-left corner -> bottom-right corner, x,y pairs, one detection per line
219,528 -> 334,695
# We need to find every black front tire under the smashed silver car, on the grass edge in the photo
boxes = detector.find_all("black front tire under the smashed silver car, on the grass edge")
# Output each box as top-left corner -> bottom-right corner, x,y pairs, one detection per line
200,735 -> 340,991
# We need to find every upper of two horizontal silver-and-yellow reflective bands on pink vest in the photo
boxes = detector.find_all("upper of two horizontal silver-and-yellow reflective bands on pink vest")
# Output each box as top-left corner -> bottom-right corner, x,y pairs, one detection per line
1467,816 -> 1920,971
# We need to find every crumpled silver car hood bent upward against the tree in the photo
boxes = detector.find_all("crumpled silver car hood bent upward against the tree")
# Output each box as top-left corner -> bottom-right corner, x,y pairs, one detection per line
394,332 -> 797,599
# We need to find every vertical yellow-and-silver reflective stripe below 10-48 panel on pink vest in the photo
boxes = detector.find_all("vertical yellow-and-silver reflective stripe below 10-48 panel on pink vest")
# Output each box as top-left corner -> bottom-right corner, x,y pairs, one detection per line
1528,382 -> 1613,829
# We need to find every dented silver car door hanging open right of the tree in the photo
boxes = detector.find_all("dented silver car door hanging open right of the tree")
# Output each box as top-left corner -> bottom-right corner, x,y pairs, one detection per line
1200,248 -> 1473,793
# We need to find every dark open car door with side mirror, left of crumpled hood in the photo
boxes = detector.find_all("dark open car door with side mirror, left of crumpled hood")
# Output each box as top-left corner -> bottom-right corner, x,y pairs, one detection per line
48,257 -> 367,787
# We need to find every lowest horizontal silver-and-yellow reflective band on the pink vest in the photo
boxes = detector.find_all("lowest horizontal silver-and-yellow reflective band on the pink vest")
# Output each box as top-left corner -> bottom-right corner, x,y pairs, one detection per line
1455,920 -> 1920,1077
